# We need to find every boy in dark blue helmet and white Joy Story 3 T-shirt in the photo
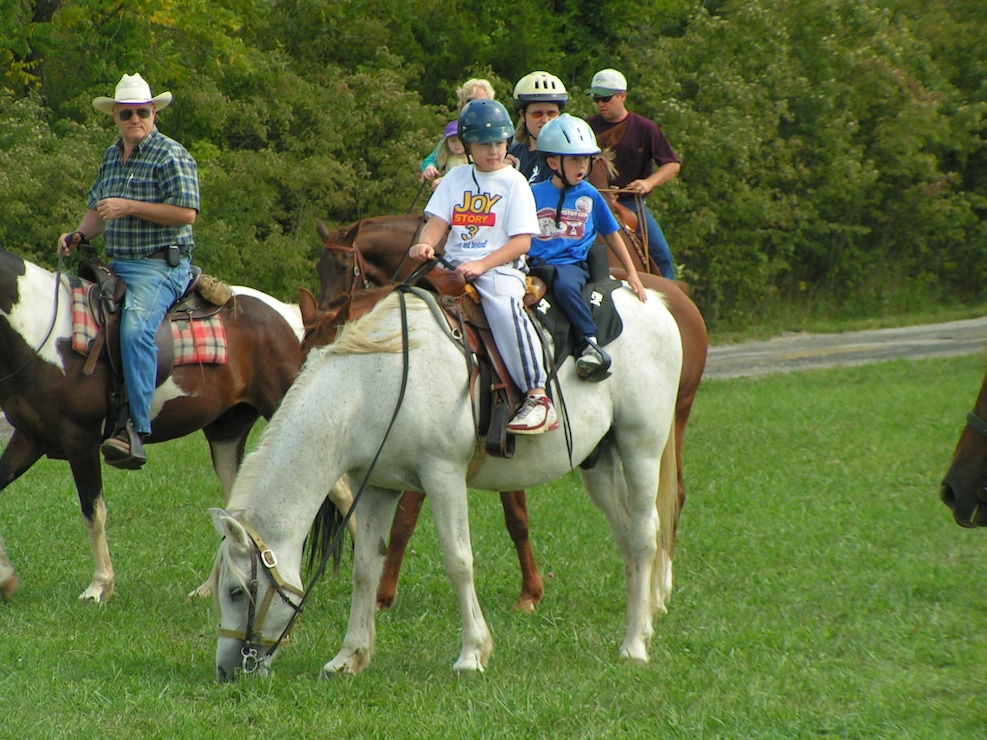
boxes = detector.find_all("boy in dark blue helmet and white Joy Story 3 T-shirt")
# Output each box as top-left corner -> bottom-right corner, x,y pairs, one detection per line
409,99 -> 559,434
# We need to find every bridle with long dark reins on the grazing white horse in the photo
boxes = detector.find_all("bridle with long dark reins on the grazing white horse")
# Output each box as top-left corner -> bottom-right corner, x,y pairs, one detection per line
218,284 -> 410,675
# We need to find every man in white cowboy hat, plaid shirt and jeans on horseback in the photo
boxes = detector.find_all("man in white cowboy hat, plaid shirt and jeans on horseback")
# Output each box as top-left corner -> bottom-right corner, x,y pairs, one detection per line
58,74 -> 199,470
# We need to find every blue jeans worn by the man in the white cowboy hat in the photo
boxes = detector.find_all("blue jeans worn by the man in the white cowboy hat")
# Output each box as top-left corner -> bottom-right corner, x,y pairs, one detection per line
110,258 -> 190,434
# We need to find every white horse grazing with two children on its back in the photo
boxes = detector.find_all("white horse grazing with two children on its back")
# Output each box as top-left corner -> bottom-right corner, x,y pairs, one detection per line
213,289 -> 682,681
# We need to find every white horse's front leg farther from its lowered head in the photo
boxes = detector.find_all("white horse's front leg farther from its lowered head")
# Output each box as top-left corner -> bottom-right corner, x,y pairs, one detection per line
422,476 -> 493,673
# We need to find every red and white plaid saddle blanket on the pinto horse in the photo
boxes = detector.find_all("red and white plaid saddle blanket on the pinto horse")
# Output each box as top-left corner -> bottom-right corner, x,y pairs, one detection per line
72,280 -> 227,365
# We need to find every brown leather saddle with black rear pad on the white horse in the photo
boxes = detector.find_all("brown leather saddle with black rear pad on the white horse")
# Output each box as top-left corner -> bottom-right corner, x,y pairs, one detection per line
418,245 -> 623,458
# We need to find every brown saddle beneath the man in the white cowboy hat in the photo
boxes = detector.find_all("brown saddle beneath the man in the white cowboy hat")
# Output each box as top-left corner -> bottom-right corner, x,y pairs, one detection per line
78,244 -> 232,437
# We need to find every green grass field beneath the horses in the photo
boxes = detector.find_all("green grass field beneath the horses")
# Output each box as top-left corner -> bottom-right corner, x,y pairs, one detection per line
0,356 -> 987,739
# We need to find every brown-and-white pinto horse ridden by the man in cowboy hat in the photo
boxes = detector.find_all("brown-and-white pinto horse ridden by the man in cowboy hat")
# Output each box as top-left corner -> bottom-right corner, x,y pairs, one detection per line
0,249 -> 352,602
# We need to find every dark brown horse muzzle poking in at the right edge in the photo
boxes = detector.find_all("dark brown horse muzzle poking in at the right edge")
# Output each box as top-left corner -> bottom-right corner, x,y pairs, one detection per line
939,358 -> 987,527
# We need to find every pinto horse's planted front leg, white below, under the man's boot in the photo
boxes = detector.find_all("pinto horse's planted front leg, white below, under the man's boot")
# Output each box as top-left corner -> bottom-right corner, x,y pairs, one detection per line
69,448 -> 116,604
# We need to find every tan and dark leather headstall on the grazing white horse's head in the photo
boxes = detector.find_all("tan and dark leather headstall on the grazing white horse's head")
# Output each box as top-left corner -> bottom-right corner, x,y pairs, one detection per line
218,522 -> 305,675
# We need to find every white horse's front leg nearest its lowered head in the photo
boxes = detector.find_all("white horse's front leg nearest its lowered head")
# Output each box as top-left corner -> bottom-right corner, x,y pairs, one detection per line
322,486 -> 398,678
